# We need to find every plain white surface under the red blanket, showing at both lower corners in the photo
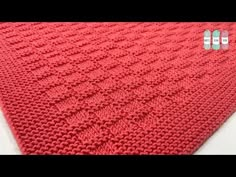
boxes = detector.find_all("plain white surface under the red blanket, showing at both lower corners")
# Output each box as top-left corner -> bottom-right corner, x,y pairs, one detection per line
0,111 -> 236,155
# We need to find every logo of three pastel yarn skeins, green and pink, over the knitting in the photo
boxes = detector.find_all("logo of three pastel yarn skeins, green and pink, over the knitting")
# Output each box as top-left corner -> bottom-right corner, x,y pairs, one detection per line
204,30 -> 229,50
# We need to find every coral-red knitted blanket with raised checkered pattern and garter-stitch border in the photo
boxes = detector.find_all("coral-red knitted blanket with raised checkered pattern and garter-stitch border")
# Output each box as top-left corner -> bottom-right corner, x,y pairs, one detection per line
0,22 -> 236,154
